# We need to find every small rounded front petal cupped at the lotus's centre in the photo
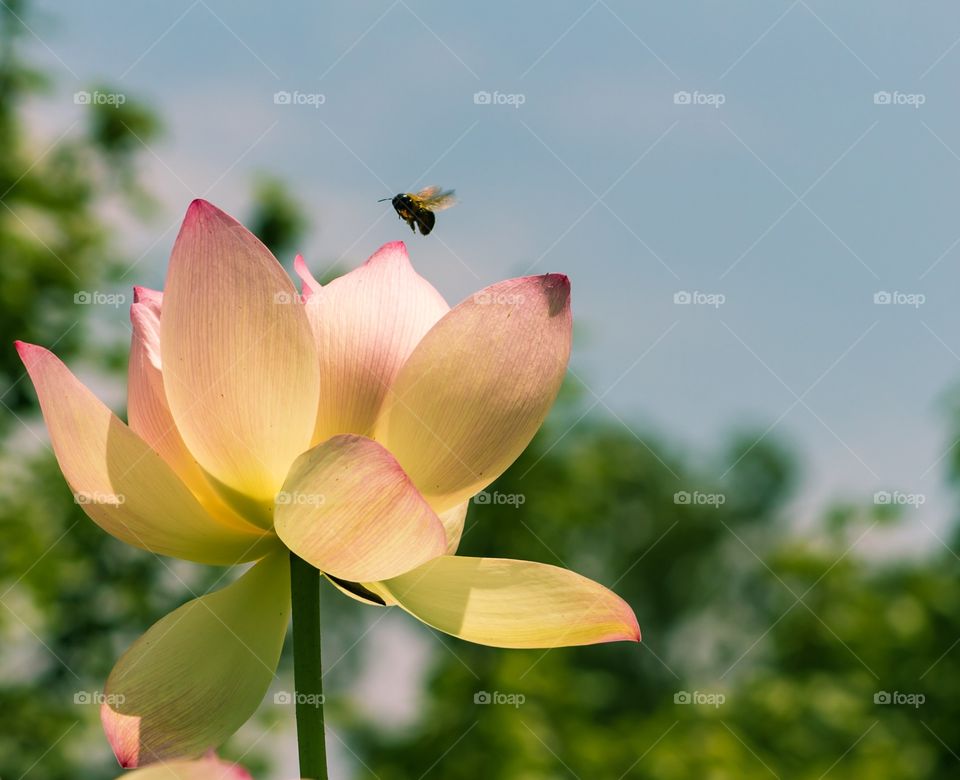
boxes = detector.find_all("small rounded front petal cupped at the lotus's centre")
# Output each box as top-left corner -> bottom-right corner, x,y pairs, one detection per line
274,435 -> 446,581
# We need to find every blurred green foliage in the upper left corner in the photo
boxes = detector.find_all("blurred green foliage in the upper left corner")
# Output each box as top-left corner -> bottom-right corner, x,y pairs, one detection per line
0,1 -> 156,426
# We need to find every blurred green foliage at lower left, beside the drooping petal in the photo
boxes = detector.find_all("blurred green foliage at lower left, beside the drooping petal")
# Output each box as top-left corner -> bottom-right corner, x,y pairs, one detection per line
0,453 -> 219,778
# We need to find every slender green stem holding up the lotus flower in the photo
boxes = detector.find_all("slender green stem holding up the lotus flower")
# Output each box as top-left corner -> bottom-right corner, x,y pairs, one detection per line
290,552 -> 327,780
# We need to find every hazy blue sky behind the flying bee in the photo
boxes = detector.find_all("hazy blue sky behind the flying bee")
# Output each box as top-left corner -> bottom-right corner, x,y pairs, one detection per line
22,0 -> 960,544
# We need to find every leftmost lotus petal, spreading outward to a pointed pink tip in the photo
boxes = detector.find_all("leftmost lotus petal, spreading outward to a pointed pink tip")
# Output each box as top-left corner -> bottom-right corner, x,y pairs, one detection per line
17,342 -> 276,564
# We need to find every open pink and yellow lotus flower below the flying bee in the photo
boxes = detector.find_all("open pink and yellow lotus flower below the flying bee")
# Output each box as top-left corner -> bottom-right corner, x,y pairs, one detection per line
17,200 -> 640,767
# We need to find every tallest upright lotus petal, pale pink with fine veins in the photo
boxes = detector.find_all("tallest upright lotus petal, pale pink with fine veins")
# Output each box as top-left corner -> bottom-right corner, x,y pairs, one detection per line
160,200 -> 319,507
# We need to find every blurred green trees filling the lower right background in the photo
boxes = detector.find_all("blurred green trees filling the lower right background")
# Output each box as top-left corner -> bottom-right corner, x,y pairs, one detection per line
355,424 -> 960,780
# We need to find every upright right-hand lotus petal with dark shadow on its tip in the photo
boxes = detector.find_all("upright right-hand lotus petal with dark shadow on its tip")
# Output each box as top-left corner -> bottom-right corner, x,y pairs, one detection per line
375,274 -> 572,512
